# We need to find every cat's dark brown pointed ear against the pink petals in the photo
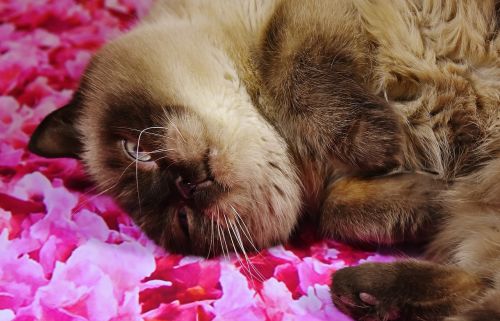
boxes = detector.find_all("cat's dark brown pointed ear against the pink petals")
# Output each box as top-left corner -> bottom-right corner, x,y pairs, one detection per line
28,97 -> 82,158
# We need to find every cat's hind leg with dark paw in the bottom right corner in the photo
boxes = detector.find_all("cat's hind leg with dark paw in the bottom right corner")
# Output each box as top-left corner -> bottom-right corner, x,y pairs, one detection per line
332,159 -> 500,321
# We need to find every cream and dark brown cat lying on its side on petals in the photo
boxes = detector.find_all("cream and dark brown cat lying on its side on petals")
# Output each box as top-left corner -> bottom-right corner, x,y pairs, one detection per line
29,0 -> 500,321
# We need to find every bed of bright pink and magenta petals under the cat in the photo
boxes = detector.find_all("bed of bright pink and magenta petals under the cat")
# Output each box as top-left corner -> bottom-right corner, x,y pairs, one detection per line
0,0 -> 391,321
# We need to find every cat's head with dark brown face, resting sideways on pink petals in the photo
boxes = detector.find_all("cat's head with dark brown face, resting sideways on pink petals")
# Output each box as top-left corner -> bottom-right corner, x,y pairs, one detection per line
30,28 -> 301,255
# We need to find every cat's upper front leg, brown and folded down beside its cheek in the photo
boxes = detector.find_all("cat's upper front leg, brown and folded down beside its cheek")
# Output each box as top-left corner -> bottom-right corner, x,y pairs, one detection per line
256,0 -> 404,174
